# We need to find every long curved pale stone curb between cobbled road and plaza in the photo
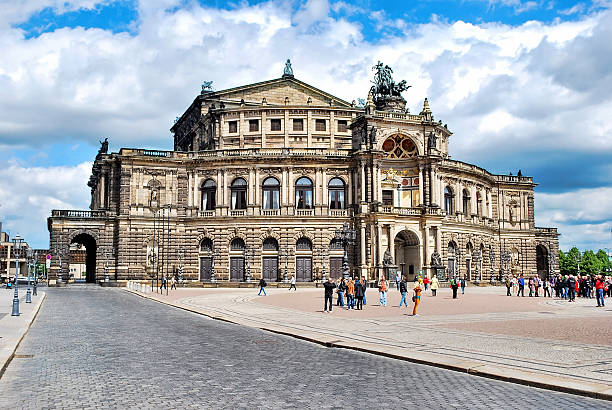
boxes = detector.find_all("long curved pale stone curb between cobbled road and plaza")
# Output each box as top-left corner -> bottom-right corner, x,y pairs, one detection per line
122,288 -> 612,401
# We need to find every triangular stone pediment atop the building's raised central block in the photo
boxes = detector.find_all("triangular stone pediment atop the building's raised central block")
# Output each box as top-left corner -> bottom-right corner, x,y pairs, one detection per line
205,78 -> 351,107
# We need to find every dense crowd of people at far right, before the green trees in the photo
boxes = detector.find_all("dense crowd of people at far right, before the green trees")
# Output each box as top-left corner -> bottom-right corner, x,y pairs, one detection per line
505,274 -> 612,307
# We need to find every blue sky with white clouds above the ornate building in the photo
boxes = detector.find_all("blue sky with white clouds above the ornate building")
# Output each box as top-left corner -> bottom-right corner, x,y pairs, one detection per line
0,0 -> 612,250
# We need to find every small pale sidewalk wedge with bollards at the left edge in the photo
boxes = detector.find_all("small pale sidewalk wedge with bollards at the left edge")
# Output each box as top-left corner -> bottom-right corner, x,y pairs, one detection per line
0,285 -> 46,377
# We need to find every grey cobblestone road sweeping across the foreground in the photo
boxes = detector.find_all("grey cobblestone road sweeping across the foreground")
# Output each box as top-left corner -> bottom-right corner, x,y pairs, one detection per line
0,287 -> 612,409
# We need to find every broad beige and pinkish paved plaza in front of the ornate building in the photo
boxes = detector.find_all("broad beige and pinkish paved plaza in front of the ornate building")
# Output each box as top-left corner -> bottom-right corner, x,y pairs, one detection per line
128,287 -> 612,400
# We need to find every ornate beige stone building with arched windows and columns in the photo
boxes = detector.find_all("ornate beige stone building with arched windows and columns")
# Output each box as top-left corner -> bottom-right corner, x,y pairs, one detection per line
48,64 -> 558,281
